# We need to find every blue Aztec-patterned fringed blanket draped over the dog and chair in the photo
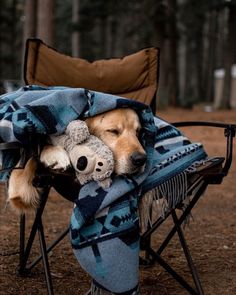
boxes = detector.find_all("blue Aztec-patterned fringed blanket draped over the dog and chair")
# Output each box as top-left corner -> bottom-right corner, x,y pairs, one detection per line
0,86 -> 207,294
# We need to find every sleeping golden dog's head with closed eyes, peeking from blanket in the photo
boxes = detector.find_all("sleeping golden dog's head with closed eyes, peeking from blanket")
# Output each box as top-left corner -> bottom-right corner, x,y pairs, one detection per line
86,108 -> 147,175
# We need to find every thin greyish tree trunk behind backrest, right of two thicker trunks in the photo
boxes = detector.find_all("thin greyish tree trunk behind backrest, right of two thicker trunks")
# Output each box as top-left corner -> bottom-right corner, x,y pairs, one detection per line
71,0 -> 80,57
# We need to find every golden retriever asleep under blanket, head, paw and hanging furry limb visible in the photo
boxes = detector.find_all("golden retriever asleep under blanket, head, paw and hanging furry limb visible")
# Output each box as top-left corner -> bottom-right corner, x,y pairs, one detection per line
8,108 -> 146,210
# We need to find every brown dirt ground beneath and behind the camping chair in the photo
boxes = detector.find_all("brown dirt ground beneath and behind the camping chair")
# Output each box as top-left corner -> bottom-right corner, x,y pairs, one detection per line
0,108 -> 236,295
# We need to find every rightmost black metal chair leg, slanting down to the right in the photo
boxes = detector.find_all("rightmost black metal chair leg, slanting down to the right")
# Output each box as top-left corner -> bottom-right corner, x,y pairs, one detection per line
172,210 -> 204,295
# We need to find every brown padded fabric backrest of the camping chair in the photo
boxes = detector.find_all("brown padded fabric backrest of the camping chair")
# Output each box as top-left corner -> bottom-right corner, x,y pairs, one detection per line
24,39 -> 159,109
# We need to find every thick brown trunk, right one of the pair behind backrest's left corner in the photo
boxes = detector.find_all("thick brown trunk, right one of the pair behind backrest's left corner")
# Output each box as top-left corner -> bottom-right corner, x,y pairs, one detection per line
37,0 -> 54,45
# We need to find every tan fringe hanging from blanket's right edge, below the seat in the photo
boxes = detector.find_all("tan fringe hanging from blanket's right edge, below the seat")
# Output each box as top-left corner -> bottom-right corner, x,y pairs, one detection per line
139,171 -> 188,232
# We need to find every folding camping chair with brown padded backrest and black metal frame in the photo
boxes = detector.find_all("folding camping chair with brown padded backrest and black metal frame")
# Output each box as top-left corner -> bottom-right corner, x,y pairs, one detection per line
2,39 -> 236,294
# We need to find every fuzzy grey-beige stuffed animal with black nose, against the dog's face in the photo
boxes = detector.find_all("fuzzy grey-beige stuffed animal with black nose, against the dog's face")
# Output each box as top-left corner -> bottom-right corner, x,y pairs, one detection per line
50,120 -> 114,188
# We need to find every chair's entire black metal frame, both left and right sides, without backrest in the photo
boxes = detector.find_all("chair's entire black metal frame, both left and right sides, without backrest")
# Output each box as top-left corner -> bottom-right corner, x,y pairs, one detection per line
0,121 -> 230,295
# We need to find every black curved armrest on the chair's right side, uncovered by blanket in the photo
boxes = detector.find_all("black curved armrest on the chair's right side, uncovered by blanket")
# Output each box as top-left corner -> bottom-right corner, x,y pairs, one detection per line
171,121 -> 236,176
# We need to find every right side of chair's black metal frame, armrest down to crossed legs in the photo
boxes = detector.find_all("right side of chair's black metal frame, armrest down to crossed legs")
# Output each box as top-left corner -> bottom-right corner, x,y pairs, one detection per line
141,121 -> 236,295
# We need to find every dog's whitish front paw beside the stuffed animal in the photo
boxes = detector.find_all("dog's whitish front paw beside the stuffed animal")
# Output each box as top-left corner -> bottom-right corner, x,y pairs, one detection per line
40,146 -> 71,170
